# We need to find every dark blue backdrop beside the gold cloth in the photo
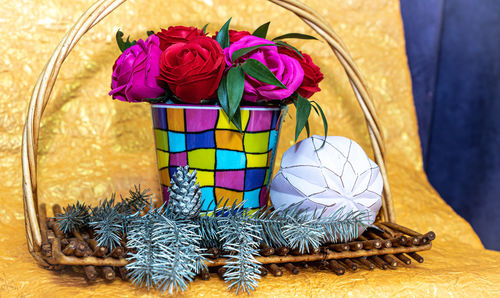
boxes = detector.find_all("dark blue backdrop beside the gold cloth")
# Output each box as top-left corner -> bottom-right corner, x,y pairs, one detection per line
401,0 -> 500,250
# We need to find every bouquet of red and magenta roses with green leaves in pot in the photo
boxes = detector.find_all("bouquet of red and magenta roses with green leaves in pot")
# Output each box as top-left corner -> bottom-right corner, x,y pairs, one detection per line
109,19 -> 328,139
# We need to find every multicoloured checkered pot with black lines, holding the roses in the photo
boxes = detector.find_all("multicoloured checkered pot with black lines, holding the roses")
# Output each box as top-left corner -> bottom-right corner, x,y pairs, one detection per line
151,104 -> 285,210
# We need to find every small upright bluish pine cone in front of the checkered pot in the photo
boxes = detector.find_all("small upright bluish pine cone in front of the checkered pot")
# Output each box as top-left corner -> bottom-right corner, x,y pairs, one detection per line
168,166 -> 201,219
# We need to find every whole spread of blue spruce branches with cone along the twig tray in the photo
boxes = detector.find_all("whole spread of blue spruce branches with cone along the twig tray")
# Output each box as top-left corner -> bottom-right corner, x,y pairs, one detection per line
57,182 -> 369,294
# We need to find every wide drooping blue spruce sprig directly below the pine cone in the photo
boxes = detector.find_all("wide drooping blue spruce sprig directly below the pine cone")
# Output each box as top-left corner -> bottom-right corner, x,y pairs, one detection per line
126,206 -> 208,294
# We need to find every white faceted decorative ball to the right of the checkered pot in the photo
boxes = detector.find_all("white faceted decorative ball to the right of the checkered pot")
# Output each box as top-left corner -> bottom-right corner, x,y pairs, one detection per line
270,135 -> 383,224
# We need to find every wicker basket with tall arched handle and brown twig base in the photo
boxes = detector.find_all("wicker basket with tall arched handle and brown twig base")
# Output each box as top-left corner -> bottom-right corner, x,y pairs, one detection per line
22,0 -> 435,275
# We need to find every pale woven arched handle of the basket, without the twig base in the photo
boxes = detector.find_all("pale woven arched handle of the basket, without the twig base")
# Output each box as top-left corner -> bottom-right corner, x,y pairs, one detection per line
22,0 -> 395,263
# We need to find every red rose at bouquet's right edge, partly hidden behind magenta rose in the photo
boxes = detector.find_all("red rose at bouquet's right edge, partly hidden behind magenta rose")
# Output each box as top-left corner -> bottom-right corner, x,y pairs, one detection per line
278,47 -> 323,98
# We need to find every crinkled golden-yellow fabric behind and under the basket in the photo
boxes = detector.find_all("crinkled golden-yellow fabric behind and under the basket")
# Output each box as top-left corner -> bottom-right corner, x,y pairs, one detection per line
0,0 -> 500,297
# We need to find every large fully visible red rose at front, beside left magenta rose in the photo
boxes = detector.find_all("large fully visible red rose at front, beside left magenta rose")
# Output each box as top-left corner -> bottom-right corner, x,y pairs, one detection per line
159,36 -> 225,103
